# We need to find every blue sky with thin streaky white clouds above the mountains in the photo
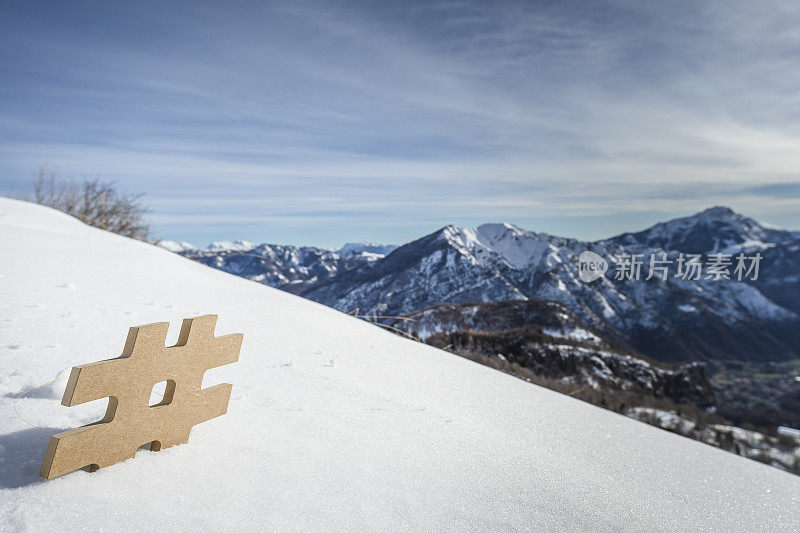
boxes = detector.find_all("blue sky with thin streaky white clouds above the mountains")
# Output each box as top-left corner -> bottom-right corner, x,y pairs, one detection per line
0,0 -> 800,247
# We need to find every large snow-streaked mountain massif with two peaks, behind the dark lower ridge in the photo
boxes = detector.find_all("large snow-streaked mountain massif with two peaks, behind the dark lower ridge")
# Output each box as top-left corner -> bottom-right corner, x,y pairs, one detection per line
300,208 -> 800,361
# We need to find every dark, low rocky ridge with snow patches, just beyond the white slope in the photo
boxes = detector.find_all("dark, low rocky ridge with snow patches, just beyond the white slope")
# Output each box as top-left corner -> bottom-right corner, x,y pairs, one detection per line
384,300 -> 715,409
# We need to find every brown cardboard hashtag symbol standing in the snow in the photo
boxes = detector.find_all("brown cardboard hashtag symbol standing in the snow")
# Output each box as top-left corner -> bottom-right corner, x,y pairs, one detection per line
40,315 -> 242,479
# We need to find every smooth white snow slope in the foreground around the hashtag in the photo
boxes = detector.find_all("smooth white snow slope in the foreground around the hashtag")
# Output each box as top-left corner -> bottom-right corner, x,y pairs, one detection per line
0,199 -> 800,531
